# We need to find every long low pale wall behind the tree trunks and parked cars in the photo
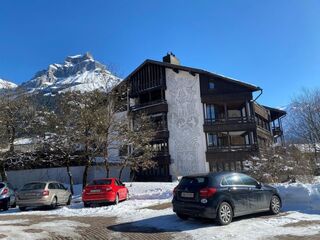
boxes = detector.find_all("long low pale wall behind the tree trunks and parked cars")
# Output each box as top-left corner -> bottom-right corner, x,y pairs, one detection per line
7,166 -> 130,188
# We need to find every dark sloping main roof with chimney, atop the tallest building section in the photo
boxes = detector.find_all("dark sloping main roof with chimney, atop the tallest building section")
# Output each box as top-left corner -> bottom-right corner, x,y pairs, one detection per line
124,59 -> 261,91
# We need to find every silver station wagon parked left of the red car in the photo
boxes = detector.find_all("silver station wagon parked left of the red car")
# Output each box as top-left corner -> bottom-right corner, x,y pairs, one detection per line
17,181 -> 72,211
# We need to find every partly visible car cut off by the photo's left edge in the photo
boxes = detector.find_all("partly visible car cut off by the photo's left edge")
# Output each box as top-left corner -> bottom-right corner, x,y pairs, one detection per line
0,182 -> 16,211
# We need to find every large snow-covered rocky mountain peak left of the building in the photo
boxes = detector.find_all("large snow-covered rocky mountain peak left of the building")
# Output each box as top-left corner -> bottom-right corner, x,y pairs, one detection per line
19,53 -> 120,95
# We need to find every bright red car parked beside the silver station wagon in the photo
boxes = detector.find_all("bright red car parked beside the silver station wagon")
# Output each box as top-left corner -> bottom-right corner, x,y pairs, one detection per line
82,178 -> 129,207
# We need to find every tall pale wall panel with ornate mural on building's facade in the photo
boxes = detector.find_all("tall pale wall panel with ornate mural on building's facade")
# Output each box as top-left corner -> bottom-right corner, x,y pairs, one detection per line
166,68 -> 209,179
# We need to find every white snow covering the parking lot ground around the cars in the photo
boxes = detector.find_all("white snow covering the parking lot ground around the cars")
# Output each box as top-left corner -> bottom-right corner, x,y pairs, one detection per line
0,181 -> 320,240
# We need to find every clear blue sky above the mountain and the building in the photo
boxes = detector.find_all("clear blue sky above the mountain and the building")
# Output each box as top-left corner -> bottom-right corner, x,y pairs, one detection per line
0,0 -> 320,107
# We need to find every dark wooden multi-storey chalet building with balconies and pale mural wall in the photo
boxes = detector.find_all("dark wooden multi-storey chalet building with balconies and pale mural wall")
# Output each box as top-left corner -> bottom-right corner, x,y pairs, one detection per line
125,53 -> 286,181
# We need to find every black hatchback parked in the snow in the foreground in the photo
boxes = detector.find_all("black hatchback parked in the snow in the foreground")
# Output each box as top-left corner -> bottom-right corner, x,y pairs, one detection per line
172,172 -> 281,225
